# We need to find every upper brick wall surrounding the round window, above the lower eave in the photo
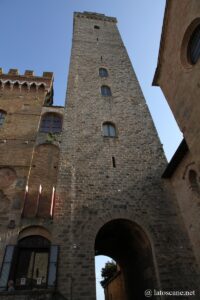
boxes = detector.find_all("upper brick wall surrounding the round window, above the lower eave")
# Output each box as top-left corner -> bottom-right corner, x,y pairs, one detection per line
157,0 -> 200,170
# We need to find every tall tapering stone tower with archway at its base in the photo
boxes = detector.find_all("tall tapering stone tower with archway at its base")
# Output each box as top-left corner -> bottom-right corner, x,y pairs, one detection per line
53,12 -> 198,300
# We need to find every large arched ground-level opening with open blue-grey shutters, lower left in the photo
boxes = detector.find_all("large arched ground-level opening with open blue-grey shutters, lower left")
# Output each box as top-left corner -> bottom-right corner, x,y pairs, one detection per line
0,235 -> 58,290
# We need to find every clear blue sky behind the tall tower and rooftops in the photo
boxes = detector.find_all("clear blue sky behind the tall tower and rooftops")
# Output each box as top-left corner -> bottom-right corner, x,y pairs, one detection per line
0,0 -> 182,300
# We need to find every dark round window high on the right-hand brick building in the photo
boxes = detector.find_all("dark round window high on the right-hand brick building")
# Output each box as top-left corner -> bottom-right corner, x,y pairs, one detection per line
187,24 -> 200,65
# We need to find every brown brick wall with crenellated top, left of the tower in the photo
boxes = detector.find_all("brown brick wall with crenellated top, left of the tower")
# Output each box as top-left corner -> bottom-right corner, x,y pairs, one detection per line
0,69 -> 53,265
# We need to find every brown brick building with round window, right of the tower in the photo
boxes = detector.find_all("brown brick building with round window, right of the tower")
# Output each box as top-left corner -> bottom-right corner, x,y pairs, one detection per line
153,0 -> 200,266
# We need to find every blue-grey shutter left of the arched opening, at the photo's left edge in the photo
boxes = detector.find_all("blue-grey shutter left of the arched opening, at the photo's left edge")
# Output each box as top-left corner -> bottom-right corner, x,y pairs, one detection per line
0,245 -> 15,291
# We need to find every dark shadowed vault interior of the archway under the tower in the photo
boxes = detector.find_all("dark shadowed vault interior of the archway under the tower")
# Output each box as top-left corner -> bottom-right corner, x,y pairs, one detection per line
95,219 -> 155,300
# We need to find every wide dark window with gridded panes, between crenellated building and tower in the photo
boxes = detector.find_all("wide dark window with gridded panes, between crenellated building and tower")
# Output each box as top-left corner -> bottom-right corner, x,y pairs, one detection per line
40,113 -> 62,133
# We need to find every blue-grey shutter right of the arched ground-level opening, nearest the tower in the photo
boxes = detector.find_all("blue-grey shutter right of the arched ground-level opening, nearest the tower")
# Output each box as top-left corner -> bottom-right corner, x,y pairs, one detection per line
48,245 -> 58,287
